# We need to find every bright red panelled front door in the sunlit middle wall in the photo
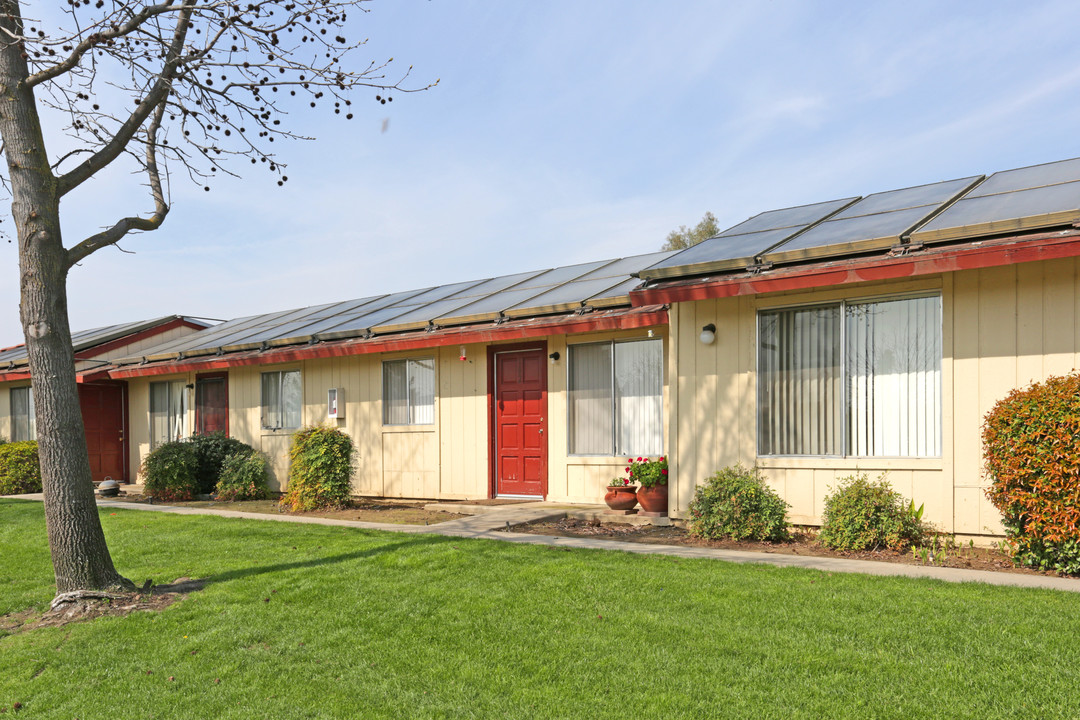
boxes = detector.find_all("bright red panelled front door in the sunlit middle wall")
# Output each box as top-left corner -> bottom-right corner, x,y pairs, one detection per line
495,349 -> 548,498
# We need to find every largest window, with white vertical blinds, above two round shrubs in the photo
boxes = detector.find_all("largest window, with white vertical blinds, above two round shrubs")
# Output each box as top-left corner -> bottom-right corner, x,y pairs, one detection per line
758,295 -> 942,458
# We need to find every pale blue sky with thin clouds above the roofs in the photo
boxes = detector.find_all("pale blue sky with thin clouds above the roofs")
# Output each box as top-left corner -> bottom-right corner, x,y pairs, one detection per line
0,0 -> 1080,347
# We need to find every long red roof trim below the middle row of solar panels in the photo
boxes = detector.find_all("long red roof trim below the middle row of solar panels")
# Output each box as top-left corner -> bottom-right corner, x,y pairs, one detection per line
108,305 -> 667,379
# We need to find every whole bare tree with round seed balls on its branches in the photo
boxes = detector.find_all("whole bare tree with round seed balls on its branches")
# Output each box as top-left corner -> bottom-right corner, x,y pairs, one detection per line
0,0 -> 437,595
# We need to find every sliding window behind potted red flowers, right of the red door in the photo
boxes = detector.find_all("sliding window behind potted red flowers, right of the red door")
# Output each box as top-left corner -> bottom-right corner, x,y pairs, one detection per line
567,340 -> 664,456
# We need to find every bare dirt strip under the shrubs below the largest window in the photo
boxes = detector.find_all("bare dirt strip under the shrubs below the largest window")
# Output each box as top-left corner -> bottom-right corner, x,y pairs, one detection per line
512,518 -> 1056,575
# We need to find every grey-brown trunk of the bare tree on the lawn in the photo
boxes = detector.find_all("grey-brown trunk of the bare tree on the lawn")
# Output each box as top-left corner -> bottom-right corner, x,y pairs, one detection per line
0,0 -> 134,593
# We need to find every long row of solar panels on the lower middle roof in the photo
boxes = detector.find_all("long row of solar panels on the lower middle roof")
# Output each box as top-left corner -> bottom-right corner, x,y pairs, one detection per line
121,253 -> 672,363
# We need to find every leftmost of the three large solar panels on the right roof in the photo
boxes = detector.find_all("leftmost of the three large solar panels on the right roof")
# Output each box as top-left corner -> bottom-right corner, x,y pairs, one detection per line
639,198 -> 859,280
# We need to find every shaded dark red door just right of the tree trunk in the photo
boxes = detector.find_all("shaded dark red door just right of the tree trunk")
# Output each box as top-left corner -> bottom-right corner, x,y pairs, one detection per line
79,383 -> 127,483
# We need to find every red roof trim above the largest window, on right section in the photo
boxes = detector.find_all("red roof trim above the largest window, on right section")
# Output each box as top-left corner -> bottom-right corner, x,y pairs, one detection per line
630,230 -> 1080,305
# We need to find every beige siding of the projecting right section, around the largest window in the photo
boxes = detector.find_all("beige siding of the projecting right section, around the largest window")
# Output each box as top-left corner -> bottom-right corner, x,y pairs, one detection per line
670,259 -> 1080,534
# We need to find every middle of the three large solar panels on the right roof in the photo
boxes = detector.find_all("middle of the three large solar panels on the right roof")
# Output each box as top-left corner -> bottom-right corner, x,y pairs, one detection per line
761,177 -> 981,262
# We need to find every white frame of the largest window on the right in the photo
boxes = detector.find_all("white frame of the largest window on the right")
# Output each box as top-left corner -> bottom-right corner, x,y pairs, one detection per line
755,291 -> 945,460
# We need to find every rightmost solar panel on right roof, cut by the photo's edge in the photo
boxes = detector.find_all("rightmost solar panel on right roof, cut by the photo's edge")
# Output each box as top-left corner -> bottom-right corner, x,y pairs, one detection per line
912,159 -> 1080,243
